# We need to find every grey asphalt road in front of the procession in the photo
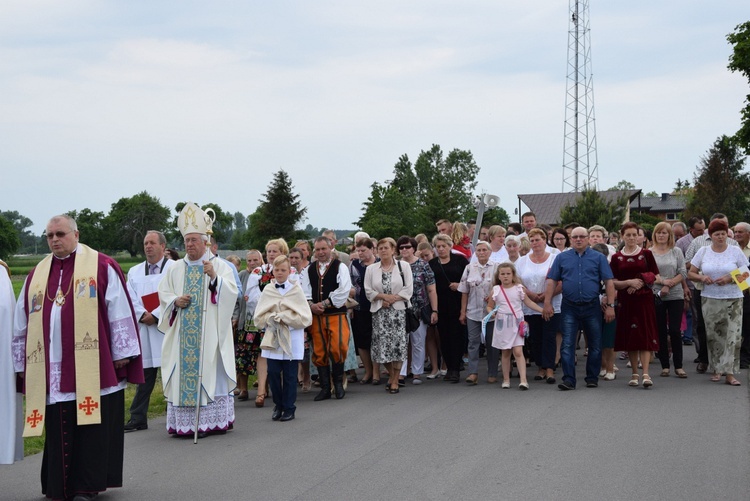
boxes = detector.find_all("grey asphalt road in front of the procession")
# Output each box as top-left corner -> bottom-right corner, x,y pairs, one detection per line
0,358 -> 750,501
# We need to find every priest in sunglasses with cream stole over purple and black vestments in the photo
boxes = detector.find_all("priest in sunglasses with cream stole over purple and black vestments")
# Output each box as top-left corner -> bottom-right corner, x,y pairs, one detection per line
13,215 -> 143,501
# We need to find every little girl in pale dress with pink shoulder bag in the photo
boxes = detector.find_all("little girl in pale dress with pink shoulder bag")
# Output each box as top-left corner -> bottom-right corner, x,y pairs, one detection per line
487,262 -> 542,390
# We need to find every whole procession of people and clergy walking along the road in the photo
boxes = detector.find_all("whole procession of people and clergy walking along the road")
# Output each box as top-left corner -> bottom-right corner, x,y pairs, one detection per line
0,204 -> 750,500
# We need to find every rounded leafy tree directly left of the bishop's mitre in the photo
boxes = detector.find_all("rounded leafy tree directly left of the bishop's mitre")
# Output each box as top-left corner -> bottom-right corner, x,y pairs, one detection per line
103,191 -> 169,256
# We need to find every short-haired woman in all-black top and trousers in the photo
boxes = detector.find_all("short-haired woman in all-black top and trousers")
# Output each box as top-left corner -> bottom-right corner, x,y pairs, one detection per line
430,235 -> 469,383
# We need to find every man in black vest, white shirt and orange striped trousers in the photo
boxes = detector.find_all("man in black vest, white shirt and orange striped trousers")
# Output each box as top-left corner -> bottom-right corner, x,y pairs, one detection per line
302,233 -> 352,401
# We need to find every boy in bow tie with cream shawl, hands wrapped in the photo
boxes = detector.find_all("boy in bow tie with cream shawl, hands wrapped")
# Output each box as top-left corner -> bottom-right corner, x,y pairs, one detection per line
253,255 -> 312,421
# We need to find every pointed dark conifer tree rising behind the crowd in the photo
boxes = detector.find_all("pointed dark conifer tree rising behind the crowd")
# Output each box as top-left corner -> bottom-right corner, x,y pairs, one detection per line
247,169 -> 307,248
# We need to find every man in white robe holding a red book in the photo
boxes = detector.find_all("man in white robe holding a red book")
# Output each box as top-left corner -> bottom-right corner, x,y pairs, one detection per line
125,230 -> 174,432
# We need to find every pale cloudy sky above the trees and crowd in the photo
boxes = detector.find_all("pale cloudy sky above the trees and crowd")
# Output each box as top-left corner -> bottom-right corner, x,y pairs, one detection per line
0,0 -> 750,233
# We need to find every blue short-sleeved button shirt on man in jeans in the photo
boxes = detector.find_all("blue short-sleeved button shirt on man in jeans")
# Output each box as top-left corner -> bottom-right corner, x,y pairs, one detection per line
547,247 -> 615,303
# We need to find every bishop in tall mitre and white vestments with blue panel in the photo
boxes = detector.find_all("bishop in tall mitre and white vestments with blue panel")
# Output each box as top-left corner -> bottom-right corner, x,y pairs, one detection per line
159,203 -> 237,438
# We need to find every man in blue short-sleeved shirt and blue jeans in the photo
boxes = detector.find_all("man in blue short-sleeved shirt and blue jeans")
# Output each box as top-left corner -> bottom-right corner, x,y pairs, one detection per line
542,226 -> 615,390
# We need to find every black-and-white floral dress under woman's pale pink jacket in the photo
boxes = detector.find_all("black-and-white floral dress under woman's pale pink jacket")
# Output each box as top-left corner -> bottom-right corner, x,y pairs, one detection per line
371,271 -> 409,364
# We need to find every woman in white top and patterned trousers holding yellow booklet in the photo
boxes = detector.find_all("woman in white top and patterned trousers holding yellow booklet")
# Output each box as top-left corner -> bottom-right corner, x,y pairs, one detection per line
688,219 -> 748,386
